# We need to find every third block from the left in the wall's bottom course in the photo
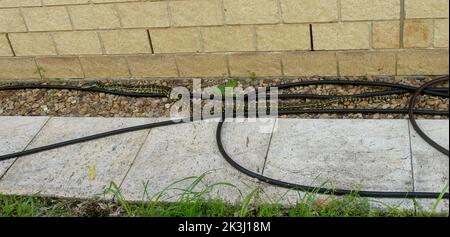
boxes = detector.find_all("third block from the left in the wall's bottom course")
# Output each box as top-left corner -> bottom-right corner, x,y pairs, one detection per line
80,56 -> 130,78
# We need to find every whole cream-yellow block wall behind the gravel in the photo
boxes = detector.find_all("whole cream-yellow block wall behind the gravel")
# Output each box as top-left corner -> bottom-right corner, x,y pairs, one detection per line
0,0 -> 449,80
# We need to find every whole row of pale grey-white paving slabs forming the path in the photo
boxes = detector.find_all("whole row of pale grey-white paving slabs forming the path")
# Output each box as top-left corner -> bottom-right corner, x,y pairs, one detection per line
0,117 -> 449,212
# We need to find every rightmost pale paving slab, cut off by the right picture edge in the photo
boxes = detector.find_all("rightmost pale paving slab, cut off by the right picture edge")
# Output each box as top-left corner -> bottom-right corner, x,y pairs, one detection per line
410,120 -> 449,212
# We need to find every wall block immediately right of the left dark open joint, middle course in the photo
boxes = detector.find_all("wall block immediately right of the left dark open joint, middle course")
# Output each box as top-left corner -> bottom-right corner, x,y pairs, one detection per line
150,28 -> 201,53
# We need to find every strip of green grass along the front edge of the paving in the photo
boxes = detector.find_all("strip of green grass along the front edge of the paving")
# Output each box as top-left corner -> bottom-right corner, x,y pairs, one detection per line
0,172 -> 448,217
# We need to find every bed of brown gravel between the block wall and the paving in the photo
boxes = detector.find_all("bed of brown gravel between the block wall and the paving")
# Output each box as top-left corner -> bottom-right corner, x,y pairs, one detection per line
0,77 -> 449,119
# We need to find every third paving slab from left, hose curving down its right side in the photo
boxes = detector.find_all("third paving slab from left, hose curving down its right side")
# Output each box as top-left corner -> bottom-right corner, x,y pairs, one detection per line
121,120 -> 275,202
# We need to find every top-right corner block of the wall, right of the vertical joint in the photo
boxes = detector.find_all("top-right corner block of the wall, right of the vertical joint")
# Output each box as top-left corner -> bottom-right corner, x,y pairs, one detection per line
405,0 -> 449,18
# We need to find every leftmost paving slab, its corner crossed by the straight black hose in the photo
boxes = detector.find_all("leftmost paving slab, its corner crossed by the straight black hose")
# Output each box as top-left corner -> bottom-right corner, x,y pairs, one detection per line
0,116 -> 49,177
